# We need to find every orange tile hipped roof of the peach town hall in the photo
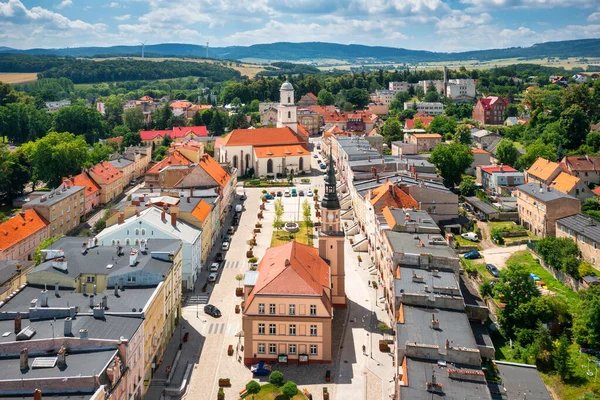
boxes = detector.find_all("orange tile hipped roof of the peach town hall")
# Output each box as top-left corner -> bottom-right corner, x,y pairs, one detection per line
248,242 -> 331,305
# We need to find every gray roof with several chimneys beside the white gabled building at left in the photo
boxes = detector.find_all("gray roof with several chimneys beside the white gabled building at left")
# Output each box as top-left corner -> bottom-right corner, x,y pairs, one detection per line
29,236 -> 181,278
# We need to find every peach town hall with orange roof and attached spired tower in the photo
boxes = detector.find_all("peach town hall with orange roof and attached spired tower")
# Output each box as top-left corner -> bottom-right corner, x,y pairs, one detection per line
242,158 -> 347,365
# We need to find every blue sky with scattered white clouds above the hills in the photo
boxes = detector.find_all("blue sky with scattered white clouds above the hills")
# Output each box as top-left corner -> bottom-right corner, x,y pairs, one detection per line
0,0 -> 600,51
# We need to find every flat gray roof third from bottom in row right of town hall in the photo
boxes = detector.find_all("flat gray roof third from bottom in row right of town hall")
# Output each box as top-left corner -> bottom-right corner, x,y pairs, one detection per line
394,267 -> 459,296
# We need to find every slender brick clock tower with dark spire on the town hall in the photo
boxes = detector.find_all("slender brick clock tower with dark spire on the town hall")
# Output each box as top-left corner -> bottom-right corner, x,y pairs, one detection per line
319,150 -> 346,307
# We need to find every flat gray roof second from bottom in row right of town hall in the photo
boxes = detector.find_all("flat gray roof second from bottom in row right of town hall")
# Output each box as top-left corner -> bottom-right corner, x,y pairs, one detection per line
396,304 -> 477,353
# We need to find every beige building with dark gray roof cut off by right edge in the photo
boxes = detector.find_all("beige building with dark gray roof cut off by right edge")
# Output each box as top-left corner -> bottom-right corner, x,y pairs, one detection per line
556,214 -> 600,268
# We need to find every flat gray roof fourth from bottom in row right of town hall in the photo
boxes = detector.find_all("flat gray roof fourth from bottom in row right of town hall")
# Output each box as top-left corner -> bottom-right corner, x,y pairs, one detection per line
384,231 -> 458,258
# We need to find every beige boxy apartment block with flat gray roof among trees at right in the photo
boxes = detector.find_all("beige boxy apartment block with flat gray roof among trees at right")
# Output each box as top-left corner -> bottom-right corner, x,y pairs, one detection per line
517,182 -> 581,238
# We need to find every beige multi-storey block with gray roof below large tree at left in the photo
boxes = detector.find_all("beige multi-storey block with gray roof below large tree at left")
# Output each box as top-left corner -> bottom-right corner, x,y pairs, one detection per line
23,186 -> 85,236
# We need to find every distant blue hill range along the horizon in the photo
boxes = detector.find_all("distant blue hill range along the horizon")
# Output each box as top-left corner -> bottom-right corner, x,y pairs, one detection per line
0,39 -> 600,63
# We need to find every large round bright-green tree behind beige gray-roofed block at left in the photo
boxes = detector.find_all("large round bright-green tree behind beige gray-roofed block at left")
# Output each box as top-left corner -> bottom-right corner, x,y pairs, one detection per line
22,132 -> 88,187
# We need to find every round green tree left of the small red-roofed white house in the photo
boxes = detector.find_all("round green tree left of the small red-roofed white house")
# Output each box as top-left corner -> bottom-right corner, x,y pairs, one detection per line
431,143 -> 475,188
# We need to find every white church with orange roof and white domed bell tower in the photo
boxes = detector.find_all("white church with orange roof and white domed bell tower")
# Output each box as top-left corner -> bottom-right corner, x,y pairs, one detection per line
215,81 -> 311,178
